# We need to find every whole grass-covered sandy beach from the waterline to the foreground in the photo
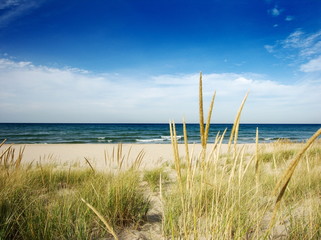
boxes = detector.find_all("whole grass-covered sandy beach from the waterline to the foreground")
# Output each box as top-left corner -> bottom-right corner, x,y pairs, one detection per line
0,141 -> 321,240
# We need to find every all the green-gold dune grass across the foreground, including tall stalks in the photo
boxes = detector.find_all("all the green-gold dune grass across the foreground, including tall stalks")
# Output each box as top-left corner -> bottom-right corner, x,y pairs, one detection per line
0,73 -> 321,239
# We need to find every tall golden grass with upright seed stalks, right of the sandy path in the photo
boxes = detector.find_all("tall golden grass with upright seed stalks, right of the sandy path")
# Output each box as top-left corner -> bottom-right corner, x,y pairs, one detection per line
163,72 -> 321,239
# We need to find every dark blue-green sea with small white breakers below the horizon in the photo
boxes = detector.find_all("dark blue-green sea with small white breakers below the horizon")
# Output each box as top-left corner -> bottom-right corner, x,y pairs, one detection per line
0,123 -> 321,144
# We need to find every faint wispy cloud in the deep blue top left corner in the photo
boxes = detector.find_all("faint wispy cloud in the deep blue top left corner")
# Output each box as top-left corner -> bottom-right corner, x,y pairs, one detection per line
0,0 -> 43,27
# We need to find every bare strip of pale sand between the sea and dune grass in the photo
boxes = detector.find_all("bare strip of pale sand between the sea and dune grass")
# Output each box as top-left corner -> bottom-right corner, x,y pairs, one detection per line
3,144 -> 262,169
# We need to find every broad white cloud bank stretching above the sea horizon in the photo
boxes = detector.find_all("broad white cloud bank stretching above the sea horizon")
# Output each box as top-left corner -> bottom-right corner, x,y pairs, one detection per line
0,59 -> 321,122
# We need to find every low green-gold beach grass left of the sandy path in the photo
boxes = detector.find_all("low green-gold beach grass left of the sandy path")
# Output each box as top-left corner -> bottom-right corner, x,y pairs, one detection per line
0,149 -> 150,239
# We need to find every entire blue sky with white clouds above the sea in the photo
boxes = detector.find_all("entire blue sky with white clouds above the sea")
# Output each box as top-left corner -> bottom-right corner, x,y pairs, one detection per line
0,0 -> 321,123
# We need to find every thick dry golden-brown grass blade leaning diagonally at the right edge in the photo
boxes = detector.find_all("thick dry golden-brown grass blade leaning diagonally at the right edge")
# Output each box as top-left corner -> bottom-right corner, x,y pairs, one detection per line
267,128 -> 321,234
